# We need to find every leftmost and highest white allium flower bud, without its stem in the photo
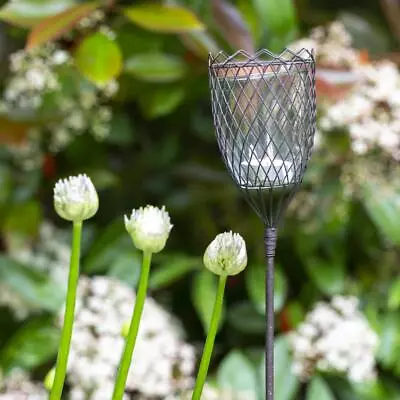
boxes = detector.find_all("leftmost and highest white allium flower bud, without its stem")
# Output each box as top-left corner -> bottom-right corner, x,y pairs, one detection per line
54,175 -> 99,222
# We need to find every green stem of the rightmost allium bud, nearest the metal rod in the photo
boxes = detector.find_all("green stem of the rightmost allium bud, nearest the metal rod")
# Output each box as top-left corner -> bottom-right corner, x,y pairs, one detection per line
192,275 -> 227,400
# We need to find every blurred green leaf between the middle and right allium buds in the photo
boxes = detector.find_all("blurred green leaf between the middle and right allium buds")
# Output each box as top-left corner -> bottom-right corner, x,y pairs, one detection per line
150,255 -> 201,289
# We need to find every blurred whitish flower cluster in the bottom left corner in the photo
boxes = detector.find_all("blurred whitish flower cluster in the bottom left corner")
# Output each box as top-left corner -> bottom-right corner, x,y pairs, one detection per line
0,369 -> 49,400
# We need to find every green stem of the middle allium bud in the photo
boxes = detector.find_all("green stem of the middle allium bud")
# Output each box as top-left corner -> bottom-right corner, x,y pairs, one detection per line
112,252 -> 151,400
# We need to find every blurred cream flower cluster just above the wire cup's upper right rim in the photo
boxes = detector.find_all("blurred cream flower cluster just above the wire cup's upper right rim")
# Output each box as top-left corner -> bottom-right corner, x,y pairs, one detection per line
290,21 -> 360,69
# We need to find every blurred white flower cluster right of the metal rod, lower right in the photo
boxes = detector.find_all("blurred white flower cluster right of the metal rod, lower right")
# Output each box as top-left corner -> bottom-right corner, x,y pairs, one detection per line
291,296 -> 379,382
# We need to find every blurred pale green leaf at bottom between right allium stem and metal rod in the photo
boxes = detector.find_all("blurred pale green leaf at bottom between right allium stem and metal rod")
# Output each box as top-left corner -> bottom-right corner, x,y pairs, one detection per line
217,350 -> 257,397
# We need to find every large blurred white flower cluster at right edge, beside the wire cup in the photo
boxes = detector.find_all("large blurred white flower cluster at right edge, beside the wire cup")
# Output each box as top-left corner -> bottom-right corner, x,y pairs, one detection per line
319,61 -> 400,162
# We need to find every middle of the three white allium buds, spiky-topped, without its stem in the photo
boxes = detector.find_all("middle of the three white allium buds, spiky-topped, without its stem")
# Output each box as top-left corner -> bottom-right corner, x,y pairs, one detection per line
125,205 -> 172,253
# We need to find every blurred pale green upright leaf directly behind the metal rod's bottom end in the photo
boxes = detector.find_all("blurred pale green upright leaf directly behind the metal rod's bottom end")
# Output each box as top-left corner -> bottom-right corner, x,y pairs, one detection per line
268,336 -> 300,400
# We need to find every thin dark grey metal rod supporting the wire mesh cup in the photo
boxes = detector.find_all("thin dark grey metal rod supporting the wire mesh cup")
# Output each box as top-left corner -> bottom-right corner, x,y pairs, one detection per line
265,228 -> 277,400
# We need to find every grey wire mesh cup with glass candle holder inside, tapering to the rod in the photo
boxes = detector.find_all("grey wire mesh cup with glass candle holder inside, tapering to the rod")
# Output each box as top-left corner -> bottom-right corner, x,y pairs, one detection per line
209,49 -> 316,227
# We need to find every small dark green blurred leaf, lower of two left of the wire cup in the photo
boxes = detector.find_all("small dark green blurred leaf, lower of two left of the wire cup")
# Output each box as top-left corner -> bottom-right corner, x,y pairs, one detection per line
139,86 -> 185,119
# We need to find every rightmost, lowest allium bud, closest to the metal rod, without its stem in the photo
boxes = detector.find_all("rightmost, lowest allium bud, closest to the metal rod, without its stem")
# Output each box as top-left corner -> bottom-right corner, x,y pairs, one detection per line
203,232 -> 247,275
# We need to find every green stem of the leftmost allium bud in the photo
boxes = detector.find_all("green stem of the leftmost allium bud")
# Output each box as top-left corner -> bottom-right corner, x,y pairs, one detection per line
50,221 -> 82,400
